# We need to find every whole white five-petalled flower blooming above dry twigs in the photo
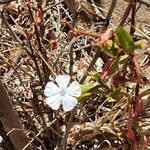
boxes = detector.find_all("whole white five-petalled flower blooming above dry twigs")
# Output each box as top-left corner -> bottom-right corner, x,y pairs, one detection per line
44,75 -> 81,112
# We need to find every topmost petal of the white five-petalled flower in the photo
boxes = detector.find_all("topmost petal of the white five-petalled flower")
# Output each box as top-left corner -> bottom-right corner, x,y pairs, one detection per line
56,75 -> 70,89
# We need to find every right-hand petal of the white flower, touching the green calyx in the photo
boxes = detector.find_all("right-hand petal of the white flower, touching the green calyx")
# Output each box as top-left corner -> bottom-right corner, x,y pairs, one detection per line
66,81 -> 82,97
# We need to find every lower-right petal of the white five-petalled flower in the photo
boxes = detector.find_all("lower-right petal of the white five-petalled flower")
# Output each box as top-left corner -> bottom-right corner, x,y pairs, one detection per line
62,94 -> 78,112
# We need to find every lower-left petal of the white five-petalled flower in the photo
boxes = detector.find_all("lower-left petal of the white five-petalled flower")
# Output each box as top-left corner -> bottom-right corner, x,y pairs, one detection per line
46,94 -> 62,110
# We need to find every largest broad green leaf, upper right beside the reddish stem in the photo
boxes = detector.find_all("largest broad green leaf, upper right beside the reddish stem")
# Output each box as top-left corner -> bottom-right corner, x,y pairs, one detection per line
116,27 -> 136,55
